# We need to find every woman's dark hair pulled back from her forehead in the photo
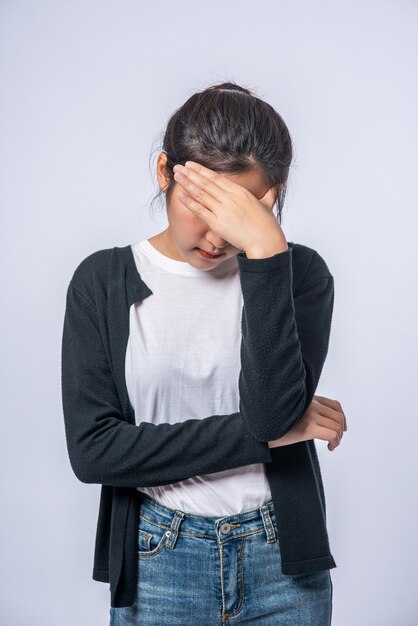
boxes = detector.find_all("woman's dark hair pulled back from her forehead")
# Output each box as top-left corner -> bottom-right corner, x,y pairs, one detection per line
149,82 -> 293,223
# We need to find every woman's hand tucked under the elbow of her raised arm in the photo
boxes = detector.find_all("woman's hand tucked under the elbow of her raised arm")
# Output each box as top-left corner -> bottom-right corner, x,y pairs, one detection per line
268,396 -> 347,452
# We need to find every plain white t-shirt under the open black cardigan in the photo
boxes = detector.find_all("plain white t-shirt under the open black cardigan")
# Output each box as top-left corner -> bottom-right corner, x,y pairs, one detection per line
125,239 -> 271,516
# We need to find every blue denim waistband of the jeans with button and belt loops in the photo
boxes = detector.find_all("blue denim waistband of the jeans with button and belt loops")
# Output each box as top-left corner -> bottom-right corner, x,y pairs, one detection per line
138,492 -> 277,542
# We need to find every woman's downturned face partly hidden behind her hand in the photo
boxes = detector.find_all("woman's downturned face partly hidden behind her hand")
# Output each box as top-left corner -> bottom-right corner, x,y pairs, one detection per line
150,152 -> 280,271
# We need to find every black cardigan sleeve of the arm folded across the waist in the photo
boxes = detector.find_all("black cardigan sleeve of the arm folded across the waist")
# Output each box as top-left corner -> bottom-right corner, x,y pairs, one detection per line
61,283 -> 272,487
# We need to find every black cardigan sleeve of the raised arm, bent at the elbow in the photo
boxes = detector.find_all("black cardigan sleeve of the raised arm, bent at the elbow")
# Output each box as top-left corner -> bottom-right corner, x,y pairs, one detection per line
237,247 -> 334,442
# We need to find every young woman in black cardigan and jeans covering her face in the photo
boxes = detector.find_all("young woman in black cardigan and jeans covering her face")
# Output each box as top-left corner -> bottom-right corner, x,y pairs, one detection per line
62,83 -> 347,626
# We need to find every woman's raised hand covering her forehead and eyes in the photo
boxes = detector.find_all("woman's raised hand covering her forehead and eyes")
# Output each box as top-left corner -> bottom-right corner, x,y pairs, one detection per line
173,161 -> 287,253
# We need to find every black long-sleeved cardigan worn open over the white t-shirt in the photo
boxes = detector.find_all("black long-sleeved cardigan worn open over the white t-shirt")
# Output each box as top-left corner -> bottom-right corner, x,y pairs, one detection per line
61,242 -> 336,607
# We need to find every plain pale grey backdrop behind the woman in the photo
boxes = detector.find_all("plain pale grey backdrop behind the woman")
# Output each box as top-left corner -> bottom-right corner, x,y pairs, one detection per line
0,0 -> 418,626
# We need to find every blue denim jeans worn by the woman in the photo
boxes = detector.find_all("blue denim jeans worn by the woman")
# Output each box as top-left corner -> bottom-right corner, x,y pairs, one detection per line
110,493 -> 333,626
